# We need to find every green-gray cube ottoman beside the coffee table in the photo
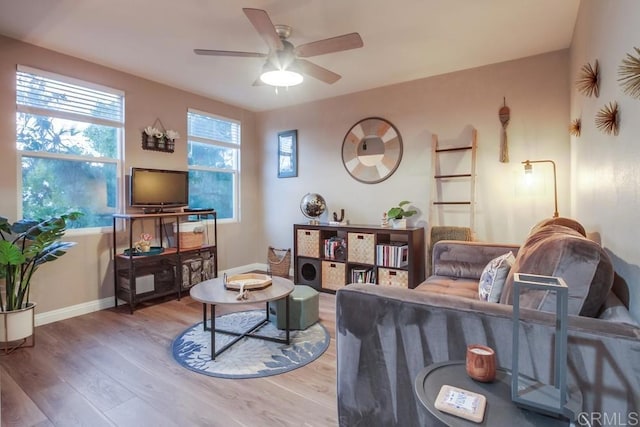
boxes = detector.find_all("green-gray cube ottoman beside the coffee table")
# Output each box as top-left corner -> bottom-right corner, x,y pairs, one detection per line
269,285 -> 320,330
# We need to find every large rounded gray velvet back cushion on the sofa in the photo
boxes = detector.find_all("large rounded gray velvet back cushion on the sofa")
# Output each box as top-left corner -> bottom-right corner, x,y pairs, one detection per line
500,224 -> 613,317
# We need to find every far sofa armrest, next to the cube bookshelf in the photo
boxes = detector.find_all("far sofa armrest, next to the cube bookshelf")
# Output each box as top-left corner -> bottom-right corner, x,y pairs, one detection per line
431,240 -> 520,280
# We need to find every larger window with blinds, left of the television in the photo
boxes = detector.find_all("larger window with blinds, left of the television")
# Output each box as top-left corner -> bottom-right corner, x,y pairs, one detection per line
16,66 -> 124,228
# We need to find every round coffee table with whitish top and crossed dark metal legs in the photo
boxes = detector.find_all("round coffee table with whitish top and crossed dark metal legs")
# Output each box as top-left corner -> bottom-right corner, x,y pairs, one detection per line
189,276 -> 294,360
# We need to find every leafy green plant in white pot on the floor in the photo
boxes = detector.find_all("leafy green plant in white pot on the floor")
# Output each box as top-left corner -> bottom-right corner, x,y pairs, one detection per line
0,212 -> 81,351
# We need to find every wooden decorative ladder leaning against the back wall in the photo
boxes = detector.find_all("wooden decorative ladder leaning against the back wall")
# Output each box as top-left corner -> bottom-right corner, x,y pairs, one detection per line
429,128 -> 477,232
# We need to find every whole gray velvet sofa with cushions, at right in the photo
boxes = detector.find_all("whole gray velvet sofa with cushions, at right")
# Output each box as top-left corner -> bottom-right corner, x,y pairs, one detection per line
336,223 -> 640,427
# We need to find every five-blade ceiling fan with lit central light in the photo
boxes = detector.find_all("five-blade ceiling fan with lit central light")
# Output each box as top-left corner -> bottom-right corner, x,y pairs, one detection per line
193,8 -> 364,87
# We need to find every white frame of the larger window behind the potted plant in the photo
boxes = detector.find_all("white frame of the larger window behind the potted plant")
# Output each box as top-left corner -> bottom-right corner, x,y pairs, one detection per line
14,64 -> 125,236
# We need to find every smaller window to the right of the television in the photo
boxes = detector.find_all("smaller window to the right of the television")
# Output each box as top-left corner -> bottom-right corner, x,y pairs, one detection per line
187,110 -> 240,219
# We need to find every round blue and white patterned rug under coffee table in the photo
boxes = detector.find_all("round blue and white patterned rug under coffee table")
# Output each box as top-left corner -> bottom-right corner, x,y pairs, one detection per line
171,310 -> 330,378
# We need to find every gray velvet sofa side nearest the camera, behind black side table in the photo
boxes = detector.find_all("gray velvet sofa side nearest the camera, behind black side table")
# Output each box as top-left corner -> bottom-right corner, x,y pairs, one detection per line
336,285 -> 640,427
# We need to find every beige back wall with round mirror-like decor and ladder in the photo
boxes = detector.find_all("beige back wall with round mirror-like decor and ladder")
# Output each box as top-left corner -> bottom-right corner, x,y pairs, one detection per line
257,51 -> 569,254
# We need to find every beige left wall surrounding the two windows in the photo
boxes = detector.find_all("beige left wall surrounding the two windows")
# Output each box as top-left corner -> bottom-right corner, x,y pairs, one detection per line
0,36 -> 266,313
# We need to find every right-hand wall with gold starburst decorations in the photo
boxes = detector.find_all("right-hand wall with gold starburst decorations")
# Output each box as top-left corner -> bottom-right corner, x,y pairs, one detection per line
570,0 -> 640,320
